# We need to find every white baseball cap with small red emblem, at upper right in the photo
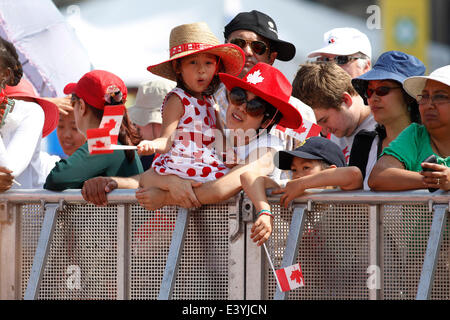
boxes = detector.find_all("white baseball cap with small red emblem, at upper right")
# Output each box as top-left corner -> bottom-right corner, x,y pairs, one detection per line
308,28 -> 372,59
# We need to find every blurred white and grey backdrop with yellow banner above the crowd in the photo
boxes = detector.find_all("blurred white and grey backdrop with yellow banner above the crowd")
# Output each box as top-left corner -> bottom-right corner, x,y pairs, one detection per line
53,0 -> 450,87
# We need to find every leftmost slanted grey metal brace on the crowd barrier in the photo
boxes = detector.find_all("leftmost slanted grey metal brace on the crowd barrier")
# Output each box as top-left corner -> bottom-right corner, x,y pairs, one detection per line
24,202 -> 63,300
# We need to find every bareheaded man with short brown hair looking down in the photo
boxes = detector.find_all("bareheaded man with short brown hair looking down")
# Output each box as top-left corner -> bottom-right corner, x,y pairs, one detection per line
292,63 -> 376,163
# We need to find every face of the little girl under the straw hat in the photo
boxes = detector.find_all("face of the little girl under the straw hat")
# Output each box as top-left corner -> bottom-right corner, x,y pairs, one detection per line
179,53 -> 217,94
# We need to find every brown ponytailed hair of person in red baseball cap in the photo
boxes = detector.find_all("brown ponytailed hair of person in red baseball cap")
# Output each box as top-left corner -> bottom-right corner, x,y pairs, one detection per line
72,93 -> 142,163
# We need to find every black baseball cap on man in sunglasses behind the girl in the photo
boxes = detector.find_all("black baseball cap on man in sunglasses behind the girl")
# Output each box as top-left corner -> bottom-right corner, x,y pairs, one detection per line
223,10 -> 295,61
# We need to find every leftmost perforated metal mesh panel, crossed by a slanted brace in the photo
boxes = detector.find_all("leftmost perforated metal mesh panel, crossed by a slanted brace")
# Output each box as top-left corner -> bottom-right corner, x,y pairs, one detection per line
22,205 -> 117,300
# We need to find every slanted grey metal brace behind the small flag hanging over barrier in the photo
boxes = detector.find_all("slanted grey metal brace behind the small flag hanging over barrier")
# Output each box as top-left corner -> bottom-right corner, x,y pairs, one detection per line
274,204 -> 308,300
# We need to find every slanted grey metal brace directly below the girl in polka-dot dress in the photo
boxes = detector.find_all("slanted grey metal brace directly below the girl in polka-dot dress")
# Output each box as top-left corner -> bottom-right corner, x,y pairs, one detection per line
158,208 -> 190,300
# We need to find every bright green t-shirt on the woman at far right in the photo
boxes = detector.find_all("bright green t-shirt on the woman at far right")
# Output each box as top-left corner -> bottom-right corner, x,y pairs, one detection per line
381,123 -> 450,172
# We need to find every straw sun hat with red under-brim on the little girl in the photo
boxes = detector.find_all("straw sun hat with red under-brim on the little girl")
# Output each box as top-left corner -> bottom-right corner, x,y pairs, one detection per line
147,22 -> 245,81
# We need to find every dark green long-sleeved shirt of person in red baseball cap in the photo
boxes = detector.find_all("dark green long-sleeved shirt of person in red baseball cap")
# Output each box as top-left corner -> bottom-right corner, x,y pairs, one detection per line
44,142 -> 144,191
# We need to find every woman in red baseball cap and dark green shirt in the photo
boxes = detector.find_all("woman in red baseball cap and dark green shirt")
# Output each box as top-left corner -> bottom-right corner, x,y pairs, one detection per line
44,70 -> 143,191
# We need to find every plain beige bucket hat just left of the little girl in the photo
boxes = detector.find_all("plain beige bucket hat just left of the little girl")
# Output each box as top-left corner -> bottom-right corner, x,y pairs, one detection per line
128,78 -> 176,126
